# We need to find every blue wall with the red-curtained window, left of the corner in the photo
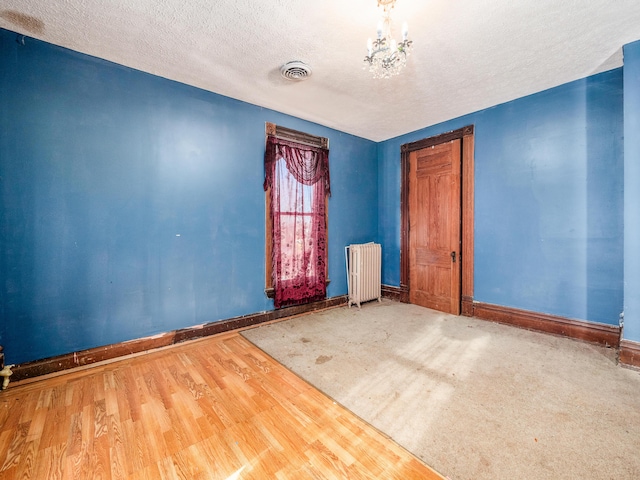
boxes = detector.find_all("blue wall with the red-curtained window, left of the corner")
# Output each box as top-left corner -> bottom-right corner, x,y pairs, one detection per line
0,30 -> 378,363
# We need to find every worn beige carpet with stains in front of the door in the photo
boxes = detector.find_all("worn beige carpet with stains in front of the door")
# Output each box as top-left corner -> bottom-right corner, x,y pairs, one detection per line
243,300 -> 640,480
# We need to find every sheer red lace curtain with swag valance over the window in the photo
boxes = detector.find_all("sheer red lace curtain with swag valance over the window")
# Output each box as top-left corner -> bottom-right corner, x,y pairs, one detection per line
264,136 -> 331,308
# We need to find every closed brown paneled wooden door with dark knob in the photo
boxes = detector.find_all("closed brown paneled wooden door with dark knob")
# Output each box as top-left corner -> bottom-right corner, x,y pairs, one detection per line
409,139 -> 462,315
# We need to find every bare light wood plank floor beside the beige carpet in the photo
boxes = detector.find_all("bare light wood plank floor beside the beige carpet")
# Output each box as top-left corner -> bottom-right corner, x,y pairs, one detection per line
0,333 -> 442,480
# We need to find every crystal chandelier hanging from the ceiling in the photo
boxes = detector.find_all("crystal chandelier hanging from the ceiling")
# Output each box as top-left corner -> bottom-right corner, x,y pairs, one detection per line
364,0 -> 413,78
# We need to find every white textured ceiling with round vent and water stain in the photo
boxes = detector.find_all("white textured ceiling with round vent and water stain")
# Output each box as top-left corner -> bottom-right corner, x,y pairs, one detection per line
0,0 -> 640,141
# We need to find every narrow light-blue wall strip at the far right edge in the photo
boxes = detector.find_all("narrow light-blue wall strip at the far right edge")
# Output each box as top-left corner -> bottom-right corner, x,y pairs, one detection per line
624,42 -> 640,342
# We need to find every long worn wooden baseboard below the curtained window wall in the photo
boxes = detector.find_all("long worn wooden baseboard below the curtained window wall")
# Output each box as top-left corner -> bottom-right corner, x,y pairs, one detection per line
11,295 -> 347,381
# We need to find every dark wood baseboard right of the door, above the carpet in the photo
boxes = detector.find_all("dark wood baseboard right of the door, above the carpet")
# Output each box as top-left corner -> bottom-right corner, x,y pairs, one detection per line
473,302 -> 620,348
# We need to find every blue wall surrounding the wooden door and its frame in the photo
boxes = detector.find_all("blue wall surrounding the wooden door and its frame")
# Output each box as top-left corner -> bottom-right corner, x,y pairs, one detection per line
378,69 -> 624,324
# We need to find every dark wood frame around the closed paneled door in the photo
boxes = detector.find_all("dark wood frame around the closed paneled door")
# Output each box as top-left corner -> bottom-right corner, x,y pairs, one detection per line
400,125 -> 474,316
